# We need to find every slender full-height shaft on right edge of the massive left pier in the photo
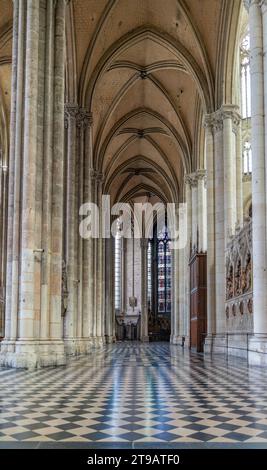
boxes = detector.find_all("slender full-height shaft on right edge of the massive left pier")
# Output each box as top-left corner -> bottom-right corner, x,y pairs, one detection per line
48,0 -> 67,347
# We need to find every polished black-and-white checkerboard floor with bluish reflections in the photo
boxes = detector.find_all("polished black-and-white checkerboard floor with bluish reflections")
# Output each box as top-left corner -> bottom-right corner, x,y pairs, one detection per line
0,342 -> 267,447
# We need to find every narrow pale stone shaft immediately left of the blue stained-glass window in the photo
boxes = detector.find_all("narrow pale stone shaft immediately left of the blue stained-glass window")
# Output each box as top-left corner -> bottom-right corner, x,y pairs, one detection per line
141,238 -> 149,342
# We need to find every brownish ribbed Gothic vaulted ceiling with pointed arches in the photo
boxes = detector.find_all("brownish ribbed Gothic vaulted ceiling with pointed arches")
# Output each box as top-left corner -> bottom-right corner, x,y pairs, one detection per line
0,0 -> 241,201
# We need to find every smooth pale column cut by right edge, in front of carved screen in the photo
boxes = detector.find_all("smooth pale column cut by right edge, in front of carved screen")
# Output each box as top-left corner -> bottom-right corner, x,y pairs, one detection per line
246,0 -> 267,364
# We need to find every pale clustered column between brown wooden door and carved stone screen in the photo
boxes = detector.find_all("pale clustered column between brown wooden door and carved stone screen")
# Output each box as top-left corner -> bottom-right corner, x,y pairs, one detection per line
205,105 -> 242,350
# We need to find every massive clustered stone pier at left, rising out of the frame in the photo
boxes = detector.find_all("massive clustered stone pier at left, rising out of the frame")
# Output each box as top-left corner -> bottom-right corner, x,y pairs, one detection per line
0,0 -> 65,367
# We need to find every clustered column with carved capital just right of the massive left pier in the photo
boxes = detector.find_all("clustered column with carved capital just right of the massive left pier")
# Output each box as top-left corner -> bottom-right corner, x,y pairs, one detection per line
63,103 -> 94,354
